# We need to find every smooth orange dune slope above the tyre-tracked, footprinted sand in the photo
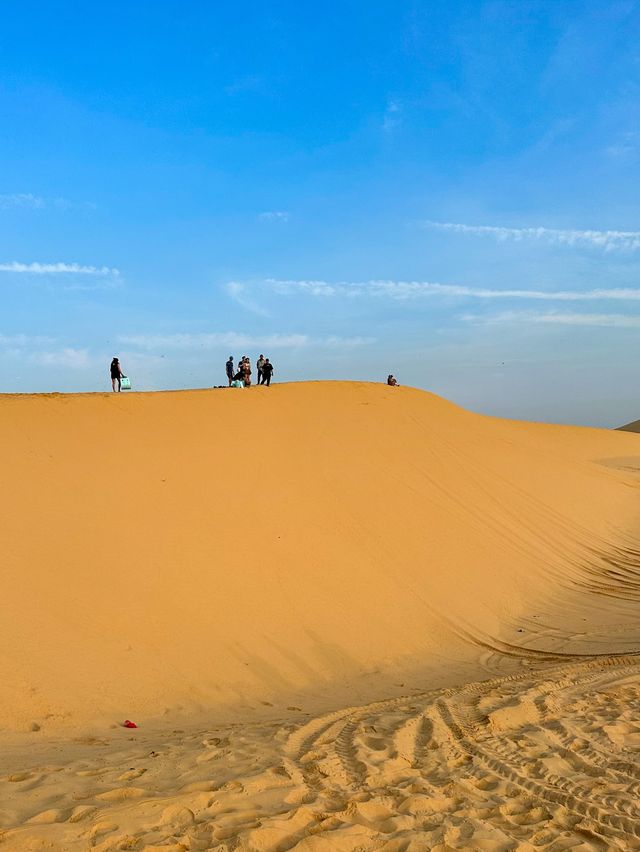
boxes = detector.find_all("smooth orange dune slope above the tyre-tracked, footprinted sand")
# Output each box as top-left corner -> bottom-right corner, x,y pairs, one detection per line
0,383 -> 640,731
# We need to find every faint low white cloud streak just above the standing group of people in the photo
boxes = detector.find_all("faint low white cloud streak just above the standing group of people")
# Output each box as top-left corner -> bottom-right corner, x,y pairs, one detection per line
118,331 -> 375,350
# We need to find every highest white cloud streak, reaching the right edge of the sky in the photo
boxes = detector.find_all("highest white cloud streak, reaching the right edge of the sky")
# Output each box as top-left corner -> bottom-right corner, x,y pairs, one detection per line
422,221 -> 640,251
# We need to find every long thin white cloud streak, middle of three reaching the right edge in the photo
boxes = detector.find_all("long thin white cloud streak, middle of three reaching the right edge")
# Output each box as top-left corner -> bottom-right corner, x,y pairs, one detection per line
265,278 -> 640,302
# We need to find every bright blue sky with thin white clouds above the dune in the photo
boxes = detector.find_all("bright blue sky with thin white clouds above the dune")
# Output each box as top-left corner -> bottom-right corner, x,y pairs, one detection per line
0,0 -> 640,425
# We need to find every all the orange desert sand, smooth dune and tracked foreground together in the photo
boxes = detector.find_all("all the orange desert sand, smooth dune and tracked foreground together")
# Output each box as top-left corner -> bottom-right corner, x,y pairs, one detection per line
0,382 -> 640,852
